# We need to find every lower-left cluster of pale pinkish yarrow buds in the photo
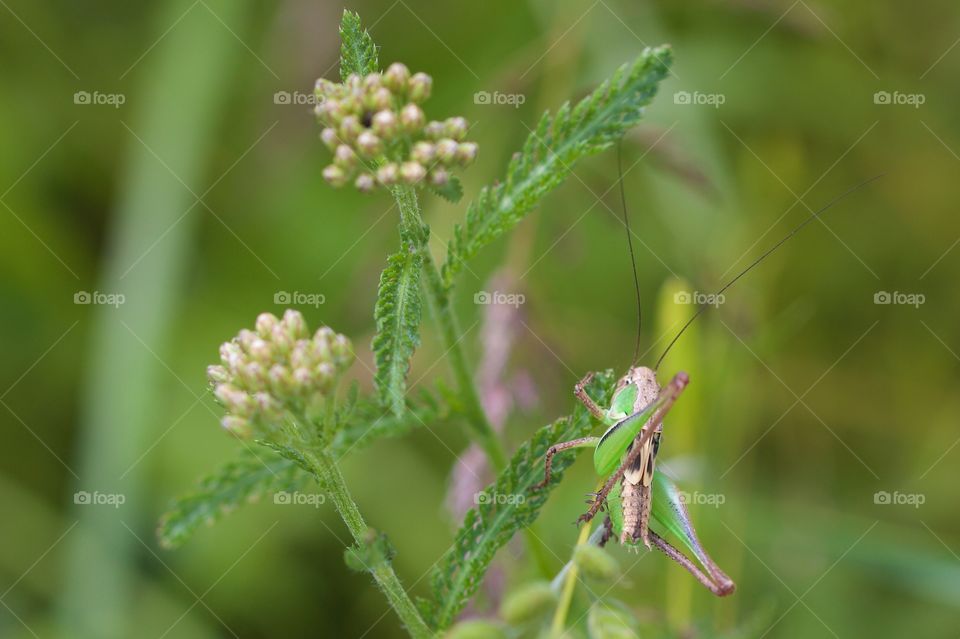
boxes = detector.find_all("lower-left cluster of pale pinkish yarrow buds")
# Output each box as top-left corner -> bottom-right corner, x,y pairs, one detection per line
207,309 -> 353,438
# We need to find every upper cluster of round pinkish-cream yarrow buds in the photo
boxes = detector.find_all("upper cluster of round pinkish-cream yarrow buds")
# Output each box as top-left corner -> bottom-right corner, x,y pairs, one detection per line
316,62 -> 477,192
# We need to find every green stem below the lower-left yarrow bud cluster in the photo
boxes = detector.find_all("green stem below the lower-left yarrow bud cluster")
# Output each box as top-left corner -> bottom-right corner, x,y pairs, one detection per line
304,449 -> 433,639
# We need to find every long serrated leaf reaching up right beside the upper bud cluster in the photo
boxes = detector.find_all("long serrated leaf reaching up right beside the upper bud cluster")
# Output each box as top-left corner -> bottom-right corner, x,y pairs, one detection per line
443,46 -> 672,287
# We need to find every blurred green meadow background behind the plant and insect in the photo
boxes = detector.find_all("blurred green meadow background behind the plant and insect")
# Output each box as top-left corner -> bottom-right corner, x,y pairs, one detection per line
0,0 -> 960,639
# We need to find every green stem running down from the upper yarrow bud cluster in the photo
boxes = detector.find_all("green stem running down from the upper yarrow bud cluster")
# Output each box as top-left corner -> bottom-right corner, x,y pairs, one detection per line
393,186 -> 506,471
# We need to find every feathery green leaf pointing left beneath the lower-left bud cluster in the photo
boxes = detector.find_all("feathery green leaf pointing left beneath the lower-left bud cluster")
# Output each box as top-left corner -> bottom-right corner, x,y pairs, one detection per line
157,449 -> 305,548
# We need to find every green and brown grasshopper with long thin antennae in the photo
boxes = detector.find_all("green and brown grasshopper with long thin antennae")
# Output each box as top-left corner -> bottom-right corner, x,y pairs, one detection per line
535,160 -> 880,597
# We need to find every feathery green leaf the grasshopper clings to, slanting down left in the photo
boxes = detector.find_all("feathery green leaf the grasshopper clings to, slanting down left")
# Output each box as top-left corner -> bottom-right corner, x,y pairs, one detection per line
426,371 -> 613,631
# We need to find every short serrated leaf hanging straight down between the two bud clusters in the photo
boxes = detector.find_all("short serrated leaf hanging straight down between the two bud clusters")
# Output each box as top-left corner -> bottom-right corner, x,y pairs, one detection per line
372,245 -> 422,416
